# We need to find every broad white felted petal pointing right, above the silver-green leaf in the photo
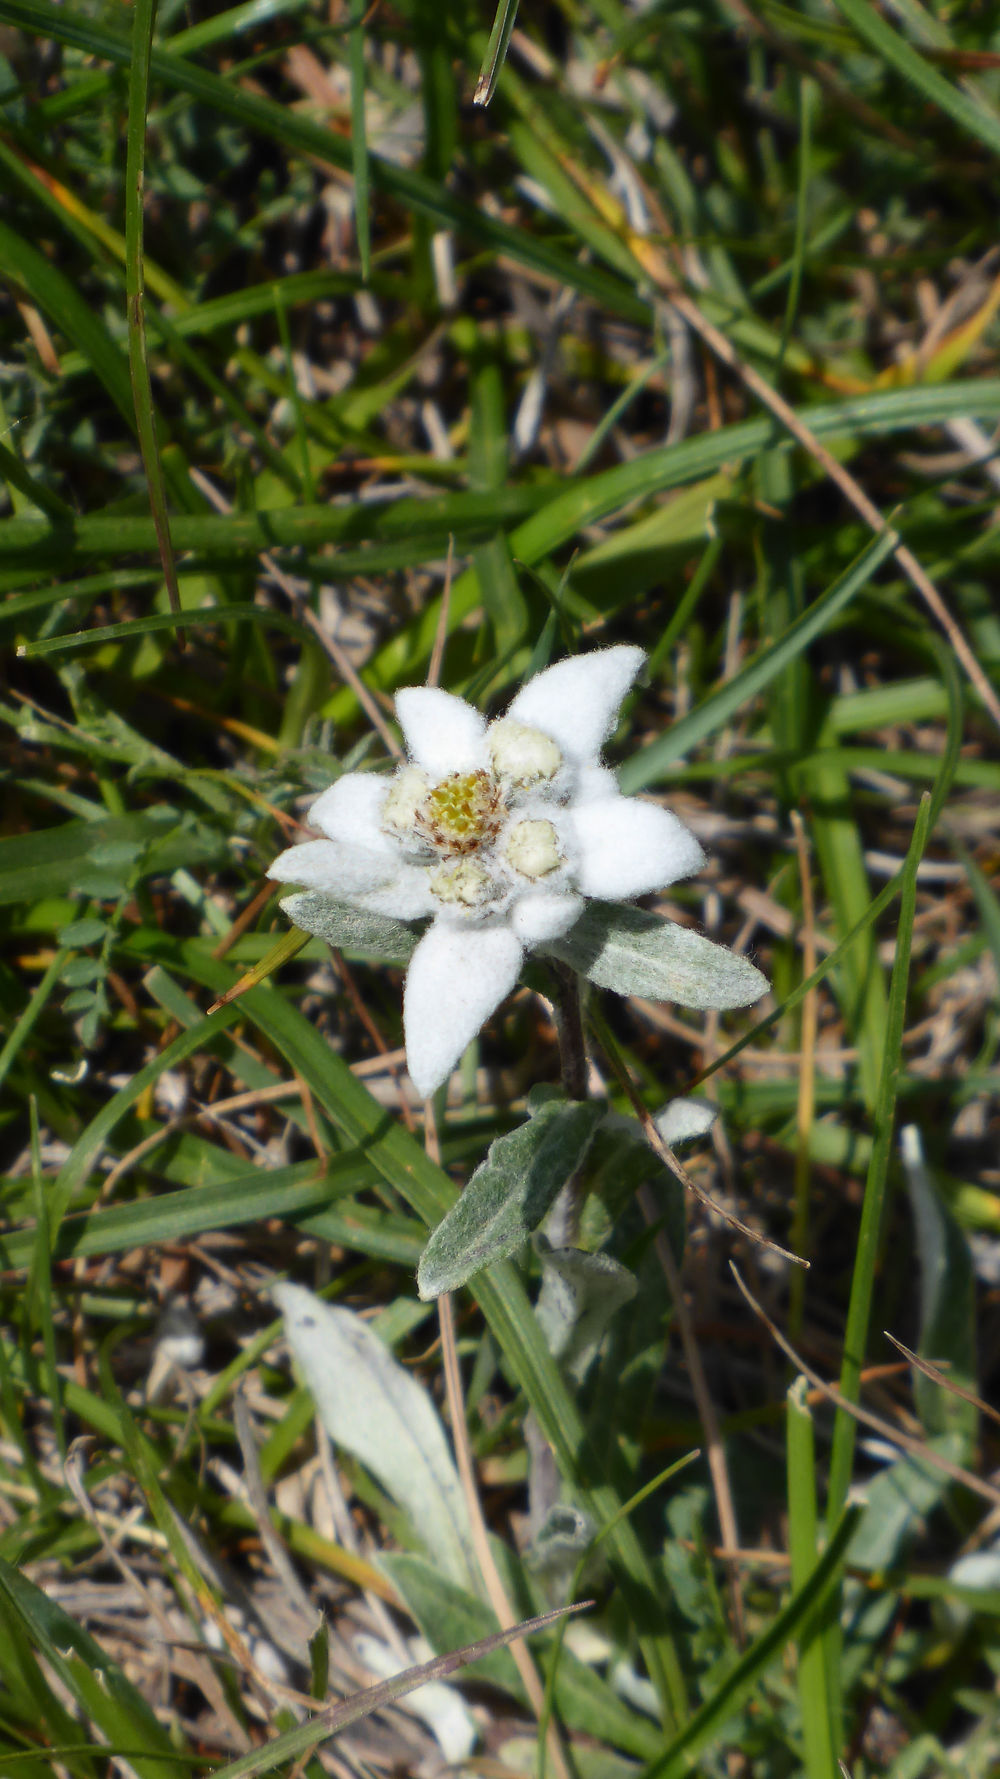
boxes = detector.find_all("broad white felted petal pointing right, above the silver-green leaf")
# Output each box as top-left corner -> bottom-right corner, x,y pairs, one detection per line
569,797 -> 705,902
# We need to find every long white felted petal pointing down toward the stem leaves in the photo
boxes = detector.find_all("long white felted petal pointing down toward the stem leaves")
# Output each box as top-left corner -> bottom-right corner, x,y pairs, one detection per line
402,920 -> 523,1099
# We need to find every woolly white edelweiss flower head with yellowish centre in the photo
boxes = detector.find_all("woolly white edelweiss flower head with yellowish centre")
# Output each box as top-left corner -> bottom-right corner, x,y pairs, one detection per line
267,646 -> 705,1096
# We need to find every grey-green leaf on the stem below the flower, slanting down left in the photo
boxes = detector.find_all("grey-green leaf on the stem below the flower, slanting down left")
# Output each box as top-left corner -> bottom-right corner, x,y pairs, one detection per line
416,1099 -> 607,1299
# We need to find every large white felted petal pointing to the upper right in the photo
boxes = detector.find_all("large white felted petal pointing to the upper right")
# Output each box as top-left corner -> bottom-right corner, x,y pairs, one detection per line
507,644 -> 646,761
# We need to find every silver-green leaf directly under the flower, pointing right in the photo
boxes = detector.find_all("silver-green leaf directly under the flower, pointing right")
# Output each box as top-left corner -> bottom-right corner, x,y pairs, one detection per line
546,902 -> 769,1010
